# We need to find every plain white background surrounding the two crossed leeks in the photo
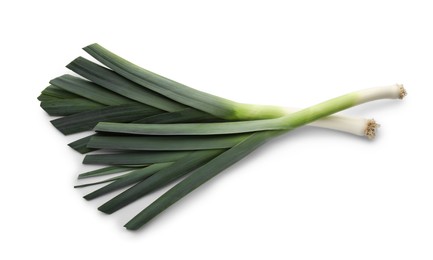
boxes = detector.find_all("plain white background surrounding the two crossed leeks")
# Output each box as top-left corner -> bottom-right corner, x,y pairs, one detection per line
0,0 -> 433,260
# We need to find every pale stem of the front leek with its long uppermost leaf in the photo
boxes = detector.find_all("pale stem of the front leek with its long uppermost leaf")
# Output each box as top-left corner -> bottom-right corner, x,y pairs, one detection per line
95,85 -> 405,135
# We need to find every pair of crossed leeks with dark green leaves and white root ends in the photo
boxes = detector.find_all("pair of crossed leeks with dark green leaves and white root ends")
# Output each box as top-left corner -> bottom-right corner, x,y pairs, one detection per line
38,44 -> 406,230
